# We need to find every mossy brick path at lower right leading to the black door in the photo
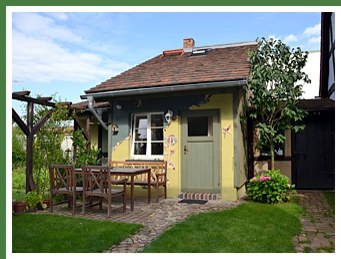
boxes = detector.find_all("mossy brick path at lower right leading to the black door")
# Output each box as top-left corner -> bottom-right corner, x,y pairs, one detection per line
293,191 -> 335,253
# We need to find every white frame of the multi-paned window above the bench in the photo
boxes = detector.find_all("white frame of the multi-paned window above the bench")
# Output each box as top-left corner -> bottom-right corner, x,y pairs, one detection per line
130,112 -> 165,160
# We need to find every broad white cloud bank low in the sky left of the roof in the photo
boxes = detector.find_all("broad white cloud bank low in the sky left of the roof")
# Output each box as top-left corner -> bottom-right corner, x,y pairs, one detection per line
12,29 -> 130,83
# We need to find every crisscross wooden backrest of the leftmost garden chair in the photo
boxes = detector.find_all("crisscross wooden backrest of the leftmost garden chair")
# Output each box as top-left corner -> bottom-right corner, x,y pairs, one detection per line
49,164 -> 76,192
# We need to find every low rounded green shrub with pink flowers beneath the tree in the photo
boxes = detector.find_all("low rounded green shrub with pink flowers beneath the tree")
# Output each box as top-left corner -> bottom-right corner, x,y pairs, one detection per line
246,170 -> 295,204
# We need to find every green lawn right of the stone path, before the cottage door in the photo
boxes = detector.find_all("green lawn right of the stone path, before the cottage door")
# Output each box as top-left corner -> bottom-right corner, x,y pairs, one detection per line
143,203 -> 302,253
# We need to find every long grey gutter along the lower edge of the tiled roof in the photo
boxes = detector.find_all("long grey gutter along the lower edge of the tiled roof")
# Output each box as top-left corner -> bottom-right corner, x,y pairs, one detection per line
81,79 -> 247,99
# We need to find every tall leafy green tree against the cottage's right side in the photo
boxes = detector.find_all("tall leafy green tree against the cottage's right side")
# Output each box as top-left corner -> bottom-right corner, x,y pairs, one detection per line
246,38 -> 310,169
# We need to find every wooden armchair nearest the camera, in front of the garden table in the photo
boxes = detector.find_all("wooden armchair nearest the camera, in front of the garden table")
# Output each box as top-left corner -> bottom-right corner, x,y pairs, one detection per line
82,166 -> 127,218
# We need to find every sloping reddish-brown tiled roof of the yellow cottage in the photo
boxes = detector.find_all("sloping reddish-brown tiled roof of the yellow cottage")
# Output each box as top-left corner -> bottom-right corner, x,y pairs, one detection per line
85,43 -> 257,94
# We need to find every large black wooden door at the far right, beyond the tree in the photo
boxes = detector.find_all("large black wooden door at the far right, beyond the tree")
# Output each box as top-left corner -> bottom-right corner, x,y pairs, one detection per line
293,111 -> 335,189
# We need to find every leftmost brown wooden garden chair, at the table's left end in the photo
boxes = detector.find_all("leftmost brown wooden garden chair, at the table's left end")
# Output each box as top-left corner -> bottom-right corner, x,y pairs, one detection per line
49,164 -> 83,215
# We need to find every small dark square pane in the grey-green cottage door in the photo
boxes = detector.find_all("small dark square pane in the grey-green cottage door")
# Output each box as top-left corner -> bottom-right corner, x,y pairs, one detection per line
187,116 -> 213,137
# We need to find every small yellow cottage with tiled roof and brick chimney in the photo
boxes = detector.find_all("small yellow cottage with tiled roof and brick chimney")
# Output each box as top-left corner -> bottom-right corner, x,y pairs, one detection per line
73,39 -> 257,201
